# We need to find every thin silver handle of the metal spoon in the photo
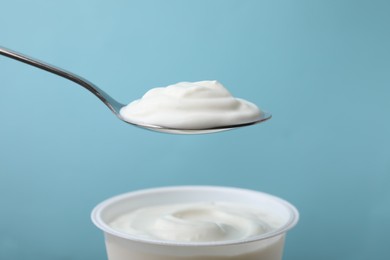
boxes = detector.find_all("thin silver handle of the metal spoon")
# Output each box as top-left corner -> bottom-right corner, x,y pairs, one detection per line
0,46 -> 123,116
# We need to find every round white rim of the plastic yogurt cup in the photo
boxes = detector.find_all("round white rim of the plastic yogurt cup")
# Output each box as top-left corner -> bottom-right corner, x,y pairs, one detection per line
91,185 -> 299,247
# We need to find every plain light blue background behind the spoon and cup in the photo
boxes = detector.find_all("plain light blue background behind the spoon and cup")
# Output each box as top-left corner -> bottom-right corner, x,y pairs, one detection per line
0,0 -> 390,260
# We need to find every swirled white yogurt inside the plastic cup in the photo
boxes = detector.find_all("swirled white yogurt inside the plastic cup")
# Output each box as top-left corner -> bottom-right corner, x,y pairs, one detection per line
110,202 -> 281,242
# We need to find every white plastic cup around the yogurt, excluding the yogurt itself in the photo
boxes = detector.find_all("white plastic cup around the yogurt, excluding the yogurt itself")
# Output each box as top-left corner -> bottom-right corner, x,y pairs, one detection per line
91,186 -> 299,260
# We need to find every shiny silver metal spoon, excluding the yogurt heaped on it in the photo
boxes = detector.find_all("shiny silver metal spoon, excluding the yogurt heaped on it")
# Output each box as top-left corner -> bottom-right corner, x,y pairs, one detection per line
0,46 -> 271,134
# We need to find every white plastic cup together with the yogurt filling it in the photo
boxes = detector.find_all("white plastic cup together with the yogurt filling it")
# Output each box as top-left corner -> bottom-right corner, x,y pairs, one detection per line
91,186 -> 299,260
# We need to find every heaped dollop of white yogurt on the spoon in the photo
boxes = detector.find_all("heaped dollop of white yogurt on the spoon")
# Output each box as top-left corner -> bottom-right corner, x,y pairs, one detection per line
120,80 -> 262,129
